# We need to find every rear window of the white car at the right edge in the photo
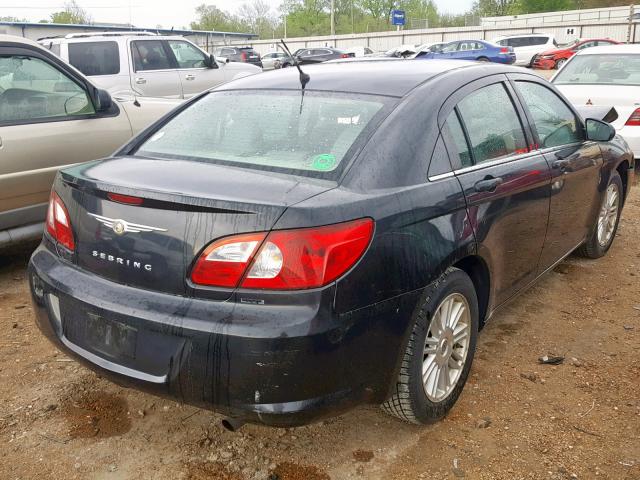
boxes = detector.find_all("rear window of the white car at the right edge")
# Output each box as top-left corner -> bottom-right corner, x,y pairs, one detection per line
553,54 -> 640,85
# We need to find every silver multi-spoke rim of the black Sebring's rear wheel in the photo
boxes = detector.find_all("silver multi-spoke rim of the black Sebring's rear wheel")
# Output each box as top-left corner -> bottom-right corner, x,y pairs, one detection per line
422,293 -> 471,403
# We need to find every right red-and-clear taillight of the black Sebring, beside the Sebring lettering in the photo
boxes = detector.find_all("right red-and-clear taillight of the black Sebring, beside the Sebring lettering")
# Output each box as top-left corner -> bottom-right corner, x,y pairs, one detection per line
191,218 -> 374,290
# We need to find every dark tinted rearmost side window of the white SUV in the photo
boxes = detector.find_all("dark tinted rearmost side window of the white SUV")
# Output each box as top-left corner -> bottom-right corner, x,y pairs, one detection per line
68,42 -> 120,76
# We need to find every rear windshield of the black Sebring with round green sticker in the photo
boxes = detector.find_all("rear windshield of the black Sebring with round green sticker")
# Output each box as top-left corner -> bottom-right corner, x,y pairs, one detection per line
137,91 -> 387,177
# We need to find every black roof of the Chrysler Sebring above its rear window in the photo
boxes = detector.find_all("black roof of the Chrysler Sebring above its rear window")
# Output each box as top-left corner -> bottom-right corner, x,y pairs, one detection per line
214,59 -> 521,97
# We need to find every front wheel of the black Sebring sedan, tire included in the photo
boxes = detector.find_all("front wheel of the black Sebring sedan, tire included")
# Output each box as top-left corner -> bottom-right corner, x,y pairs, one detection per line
576,170 -> 624,259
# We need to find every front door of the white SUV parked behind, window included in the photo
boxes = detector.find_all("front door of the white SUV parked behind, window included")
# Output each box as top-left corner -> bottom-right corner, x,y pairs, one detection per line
167,40 -> 224,98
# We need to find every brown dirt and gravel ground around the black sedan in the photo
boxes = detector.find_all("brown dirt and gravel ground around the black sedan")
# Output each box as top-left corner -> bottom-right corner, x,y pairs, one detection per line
0,187 -> 640,480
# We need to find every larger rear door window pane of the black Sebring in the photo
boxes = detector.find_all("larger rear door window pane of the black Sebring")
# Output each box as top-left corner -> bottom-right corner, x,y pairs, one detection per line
458,83 -> 528,163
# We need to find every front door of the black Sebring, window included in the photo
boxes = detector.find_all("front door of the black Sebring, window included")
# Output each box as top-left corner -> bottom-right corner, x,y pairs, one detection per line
512,75 -> 603,271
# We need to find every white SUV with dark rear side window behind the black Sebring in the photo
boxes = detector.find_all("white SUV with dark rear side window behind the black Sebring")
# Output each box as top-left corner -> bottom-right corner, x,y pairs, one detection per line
40,32 -> 261,98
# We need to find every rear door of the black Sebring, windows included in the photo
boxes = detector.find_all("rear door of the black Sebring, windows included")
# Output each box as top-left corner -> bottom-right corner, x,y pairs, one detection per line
441,75 -> 550,305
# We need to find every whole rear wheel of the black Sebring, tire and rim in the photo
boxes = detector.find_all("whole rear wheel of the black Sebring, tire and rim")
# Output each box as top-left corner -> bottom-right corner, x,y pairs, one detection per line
382,268 -> 478,424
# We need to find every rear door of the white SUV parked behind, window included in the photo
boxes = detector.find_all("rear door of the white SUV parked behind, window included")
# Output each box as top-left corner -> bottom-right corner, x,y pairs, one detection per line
130,40 -> 182,98
